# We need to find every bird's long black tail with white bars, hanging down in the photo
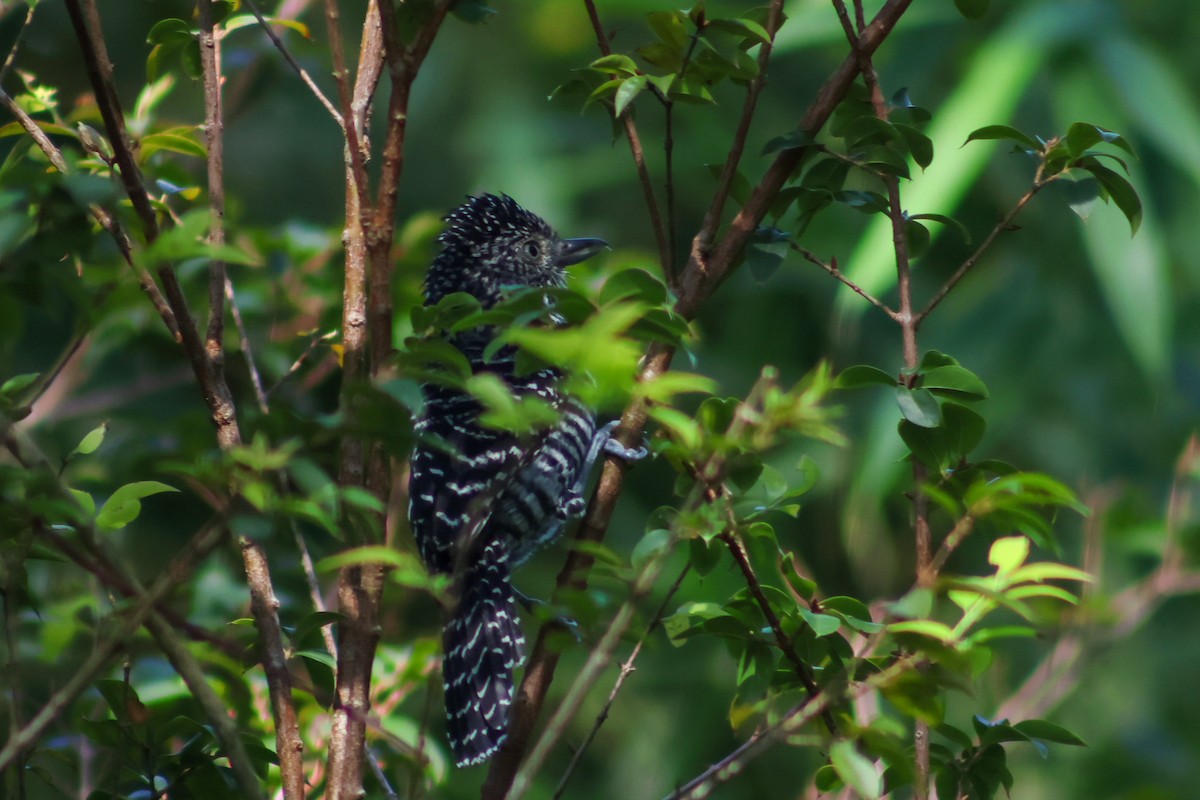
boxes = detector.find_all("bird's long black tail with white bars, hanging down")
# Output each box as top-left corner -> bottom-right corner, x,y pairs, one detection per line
442,541 -> 524,766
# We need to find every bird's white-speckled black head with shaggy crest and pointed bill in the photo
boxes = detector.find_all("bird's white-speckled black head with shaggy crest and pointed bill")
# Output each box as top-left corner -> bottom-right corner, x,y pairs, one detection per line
425,194 -> 607,307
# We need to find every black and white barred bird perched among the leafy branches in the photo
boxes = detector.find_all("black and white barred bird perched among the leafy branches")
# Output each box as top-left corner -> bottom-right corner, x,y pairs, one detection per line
409,194 -> 642,766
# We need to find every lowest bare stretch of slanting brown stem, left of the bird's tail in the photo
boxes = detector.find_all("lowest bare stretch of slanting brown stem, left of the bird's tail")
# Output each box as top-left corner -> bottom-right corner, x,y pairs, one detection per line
241,539 -> 305,800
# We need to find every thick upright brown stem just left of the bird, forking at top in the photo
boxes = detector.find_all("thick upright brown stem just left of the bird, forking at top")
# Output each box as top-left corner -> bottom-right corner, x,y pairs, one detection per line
325,0 -> 451,800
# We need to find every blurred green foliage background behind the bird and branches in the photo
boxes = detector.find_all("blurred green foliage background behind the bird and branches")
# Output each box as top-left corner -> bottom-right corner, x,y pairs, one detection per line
0,0 -> 1200,800
